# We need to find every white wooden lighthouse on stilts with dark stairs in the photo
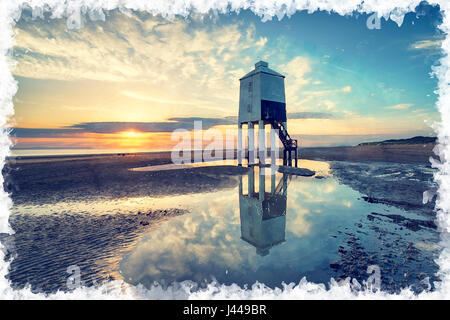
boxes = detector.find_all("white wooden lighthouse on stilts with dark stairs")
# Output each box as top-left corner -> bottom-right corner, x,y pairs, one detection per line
238,61 -> 298,166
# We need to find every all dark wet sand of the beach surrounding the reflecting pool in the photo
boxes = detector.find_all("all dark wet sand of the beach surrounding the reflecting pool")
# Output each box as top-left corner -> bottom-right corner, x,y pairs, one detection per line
0,145 -> 438,292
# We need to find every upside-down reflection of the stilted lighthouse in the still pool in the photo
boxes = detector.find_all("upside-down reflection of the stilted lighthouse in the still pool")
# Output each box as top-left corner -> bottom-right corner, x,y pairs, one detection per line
239,167 -> 289,256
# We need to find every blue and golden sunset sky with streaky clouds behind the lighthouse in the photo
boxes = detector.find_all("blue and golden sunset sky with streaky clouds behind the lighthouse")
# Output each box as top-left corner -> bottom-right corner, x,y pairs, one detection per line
11,5 -> 443,153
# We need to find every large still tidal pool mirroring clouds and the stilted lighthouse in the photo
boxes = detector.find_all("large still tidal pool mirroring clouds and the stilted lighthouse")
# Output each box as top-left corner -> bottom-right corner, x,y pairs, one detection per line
120,161 -> 438,290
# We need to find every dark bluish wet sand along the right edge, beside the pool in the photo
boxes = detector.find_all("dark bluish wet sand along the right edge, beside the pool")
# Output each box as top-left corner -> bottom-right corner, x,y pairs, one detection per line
330,161 -> 440,292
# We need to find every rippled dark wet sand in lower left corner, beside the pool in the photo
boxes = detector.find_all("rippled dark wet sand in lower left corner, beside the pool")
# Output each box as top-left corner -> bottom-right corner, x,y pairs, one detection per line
0,208 -> 187,292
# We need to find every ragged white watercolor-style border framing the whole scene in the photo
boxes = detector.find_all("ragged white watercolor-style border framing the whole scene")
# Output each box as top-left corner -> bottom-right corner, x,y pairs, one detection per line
0,0 -> 450,299
